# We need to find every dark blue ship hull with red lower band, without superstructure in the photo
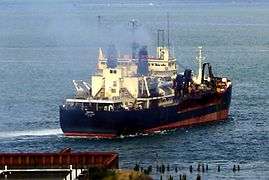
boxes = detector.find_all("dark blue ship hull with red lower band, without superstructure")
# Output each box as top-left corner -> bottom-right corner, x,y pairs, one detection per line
60,86 -> 232,138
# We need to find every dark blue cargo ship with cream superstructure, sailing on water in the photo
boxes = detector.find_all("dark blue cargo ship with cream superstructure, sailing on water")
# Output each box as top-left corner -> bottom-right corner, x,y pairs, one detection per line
60,33 -> 232,138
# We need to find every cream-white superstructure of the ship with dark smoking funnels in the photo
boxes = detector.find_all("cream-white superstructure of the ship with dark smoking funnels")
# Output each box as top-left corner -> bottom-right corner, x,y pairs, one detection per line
74,38 -> 177,109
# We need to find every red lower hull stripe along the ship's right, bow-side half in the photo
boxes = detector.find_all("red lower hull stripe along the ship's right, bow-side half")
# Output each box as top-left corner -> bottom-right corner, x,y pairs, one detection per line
145,110 -> 228,133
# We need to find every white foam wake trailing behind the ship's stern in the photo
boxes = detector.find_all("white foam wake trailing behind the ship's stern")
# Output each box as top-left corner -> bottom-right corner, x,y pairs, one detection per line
0,129 -> 63,138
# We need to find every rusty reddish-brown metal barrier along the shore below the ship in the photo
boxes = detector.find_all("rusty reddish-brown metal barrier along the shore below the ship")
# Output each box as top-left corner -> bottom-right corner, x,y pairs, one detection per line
0,149 -> 119,169
